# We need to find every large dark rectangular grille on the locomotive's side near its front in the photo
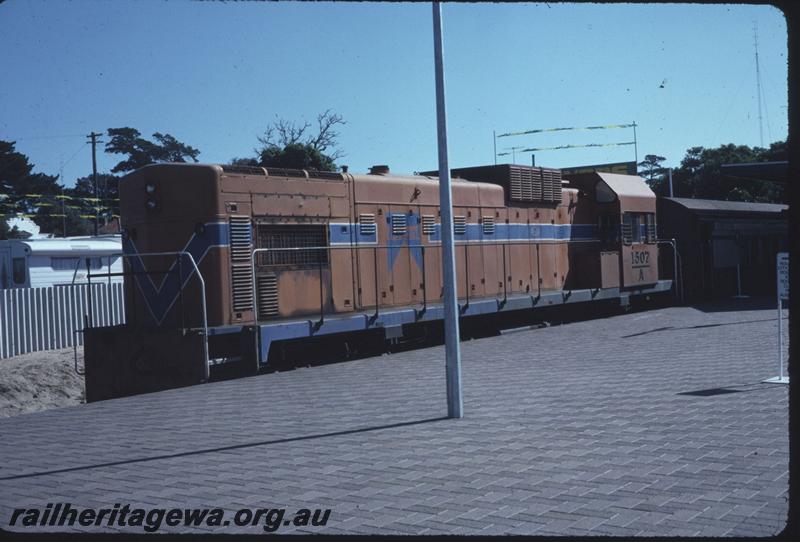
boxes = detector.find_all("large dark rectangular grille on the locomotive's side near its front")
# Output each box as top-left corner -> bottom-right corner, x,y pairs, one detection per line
256,224 -> 328,267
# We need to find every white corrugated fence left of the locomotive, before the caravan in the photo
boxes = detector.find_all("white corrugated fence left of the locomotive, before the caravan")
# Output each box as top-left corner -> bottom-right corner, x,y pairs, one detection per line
0,283 -> 125,359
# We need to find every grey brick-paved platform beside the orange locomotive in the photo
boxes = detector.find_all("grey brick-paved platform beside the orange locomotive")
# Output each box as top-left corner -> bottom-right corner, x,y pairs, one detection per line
0,300 -> 788,536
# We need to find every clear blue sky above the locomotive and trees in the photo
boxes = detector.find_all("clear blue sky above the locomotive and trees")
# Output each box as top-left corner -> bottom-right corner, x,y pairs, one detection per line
0,0 -> 788,185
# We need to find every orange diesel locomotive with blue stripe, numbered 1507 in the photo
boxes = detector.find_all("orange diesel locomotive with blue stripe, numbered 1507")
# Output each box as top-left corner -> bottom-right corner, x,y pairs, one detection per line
84,164 -> 671,401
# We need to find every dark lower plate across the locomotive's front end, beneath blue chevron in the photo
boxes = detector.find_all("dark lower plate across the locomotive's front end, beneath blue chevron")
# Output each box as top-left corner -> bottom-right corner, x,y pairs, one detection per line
84,325 -> 205,402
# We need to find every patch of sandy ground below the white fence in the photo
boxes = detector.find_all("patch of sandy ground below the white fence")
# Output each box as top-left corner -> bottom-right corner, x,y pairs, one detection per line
0,347 -> 84,417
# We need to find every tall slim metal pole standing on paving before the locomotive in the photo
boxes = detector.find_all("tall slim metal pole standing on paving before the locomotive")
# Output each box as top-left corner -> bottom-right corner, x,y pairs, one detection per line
433,2 -> 463,418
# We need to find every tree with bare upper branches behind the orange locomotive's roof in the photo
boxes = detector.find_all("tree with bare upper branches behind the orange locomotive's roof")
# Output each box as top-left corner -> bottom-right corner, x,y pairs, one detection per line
256,109 -> 347,171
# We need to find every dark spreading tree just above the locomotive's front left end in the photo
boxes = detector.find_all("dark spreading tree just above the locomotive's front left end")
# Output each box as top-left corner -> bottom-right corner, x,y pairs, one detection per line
105,127 -> 200,173
